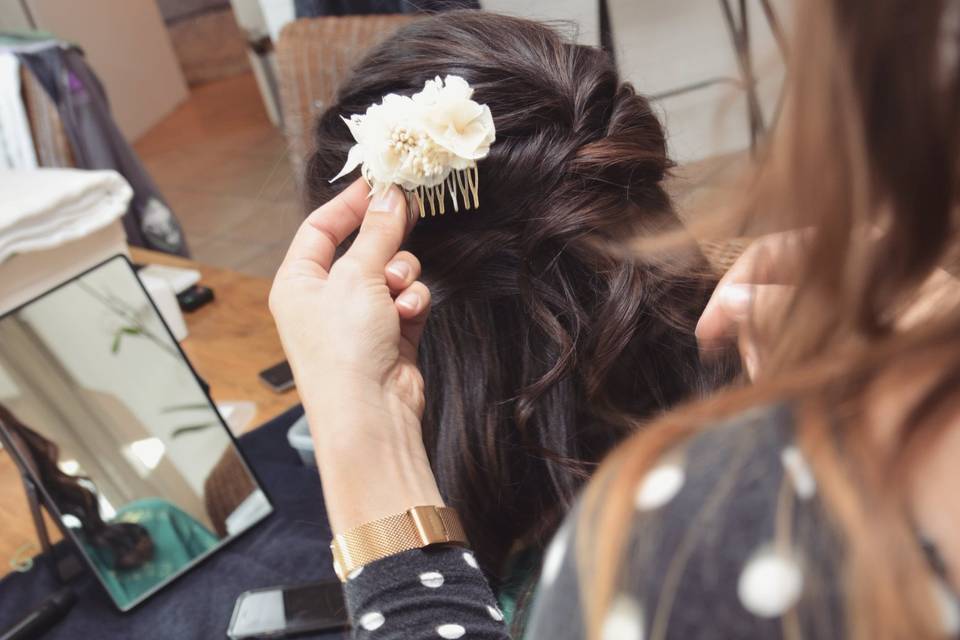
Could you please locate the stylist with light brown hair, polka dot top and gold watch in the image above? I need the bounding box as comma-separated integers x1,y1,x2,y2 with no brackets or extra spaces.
270,0,960,640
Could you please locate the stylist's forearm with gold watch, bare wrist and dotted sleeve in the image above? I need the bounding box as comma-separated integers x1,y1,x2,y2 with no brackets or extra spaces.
304,385,509,640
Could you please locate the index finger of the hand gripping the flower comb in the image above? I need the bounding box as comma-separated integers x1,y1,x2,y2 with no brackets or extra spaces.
282,178,370,272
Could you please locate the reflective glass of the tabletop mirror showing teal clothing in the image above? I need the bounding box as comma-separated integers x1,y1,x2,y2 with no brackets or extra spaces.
0,257,271,609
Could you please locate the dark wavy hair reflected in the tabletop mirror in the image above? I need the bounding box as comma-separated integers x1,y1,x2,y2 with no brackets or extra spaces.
0,404,153,570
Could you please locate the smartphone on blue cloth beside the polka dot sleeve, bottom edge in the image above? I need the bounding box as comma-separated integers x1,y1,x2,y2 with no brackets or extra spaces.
227,581,348,640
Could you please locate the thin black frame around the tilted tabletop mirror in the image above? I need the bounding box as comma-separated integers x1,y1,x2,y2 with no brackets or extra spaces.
0,253,277,613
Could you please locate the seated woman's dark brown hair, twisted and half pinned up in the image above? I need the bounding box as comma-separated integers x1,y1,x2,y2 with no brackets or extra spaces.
306,12,728,579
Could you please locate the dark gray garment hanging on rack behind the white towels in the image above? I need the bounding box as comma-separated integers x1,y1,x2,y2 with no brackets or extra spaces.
17,44,190,256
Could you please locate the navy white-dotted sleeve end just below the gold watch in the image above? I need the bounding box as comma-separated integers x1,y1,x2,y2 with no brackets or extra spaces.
344,547,510,640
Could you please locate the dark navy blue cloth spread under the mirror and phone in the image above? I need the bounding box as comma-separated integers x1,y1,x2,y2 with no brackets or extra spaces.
0,407,344,640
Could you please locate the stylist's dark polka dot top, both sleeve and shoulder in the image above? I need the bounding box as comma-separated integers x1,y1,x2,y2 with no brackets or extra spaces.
345,407,960,640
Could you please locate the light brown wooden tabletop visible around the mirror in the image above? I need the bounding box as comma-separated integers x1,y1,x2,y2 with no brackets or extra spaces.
0,248,300,575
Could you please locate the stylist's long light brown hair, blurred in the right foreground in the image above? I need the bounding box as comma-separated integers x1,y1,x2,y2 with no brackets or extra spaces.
580,0,960,640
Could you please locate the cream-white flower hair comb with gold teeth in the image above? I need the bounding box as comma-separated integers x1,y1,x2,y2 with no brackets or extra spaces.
330,76,496,218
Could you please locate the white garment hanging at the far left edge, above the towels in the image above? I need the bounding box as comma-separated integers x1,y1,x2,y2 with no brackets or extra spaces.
0,51,37,169
